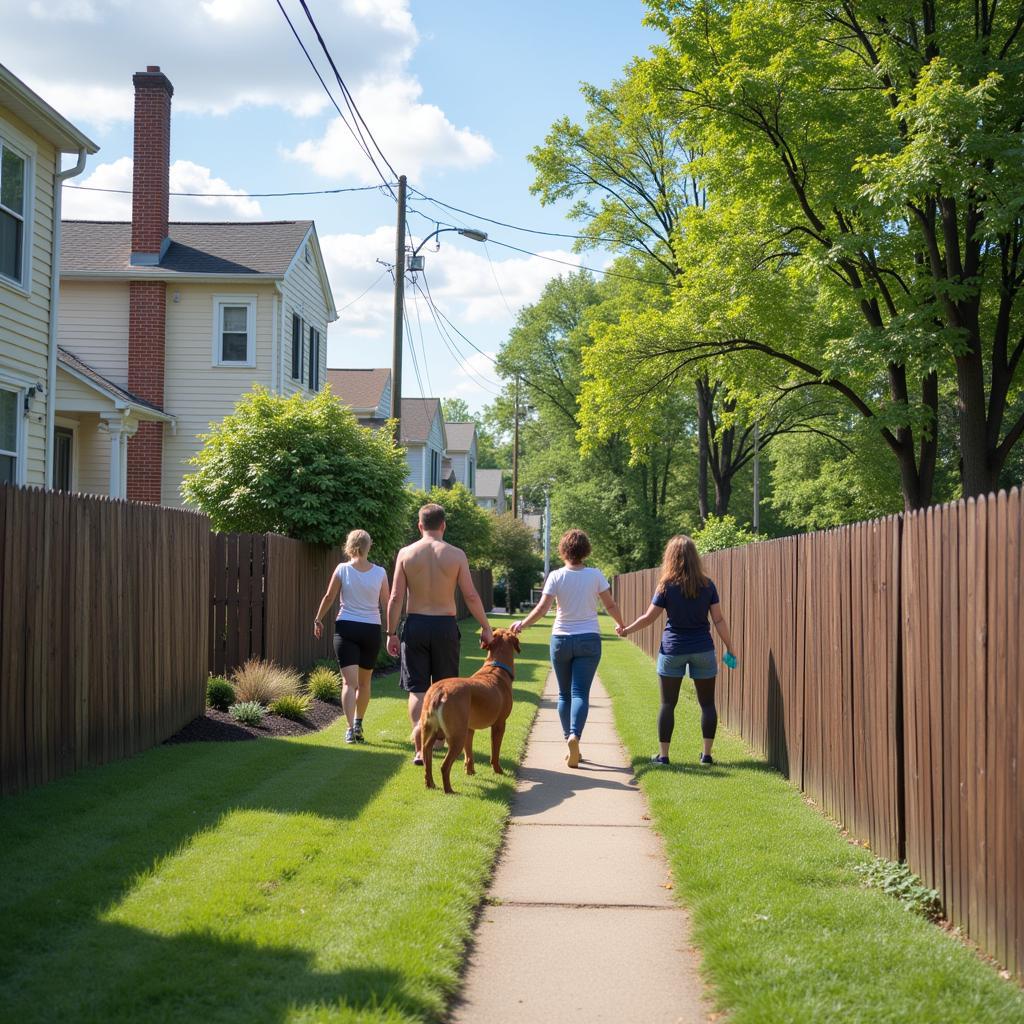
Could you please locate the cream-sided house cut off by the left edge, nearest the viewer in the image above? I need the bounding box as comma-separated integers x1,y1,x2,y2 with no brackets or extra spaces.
0,65,97,486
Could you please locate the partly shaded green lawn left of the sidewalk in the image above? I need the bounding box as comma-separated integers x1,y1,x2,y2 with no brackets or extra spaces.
0,624,548,1024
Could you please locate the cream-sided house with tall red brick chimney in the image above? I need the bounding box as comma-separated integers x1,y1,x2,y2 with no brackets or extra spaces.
56,67,337,505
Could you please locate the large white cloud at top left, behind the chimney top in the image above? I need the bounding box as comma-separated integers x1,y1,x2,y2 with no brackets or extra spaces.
0,0,418,128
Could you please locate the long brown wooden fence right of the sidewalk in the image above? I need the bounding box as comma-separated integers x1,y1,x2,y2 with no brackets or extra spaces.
615,490,1024,975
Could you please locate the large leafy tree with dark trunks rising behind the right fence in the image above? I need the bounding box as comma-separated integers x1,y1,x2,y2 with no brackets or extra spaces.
648,0,1024,499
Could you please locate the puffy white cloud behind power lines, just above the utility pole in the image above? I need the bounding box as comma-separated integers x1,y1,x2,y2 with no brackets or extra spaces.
287,77,495,182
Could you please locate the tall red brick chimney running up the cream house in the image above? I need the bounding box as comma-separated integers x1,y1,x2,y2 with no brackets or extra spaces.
128,66,174,505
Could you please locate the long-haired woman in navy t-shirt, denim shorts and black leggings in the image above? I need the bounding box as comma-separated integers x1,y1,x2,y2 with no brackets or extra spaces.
615,535,732,765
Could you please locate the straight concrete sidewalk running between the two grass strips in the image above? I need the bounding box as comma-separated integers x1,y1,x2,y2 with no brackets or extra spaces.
451,676,708,1024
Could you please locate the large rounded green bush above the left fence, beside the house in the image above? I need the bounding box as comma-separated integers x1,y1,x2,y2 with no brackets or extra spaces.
181,387,409,559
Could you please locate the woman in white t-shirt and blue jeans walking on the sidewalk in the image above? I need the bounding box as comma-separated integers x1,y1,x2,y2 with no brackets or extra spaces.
512,529,623,768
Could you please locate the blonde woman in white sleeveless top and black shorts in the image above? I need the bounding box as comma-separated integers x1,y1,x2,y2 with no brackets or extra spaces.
313,529,390,743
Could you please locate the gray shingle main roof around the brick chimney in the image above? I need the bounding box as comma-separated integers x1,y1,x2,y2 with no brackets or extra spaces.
60,220,312,278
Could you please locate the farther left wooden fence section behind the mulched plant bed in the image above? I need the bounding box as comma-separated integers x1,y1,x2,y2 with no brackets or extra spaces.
209,534,494,675
